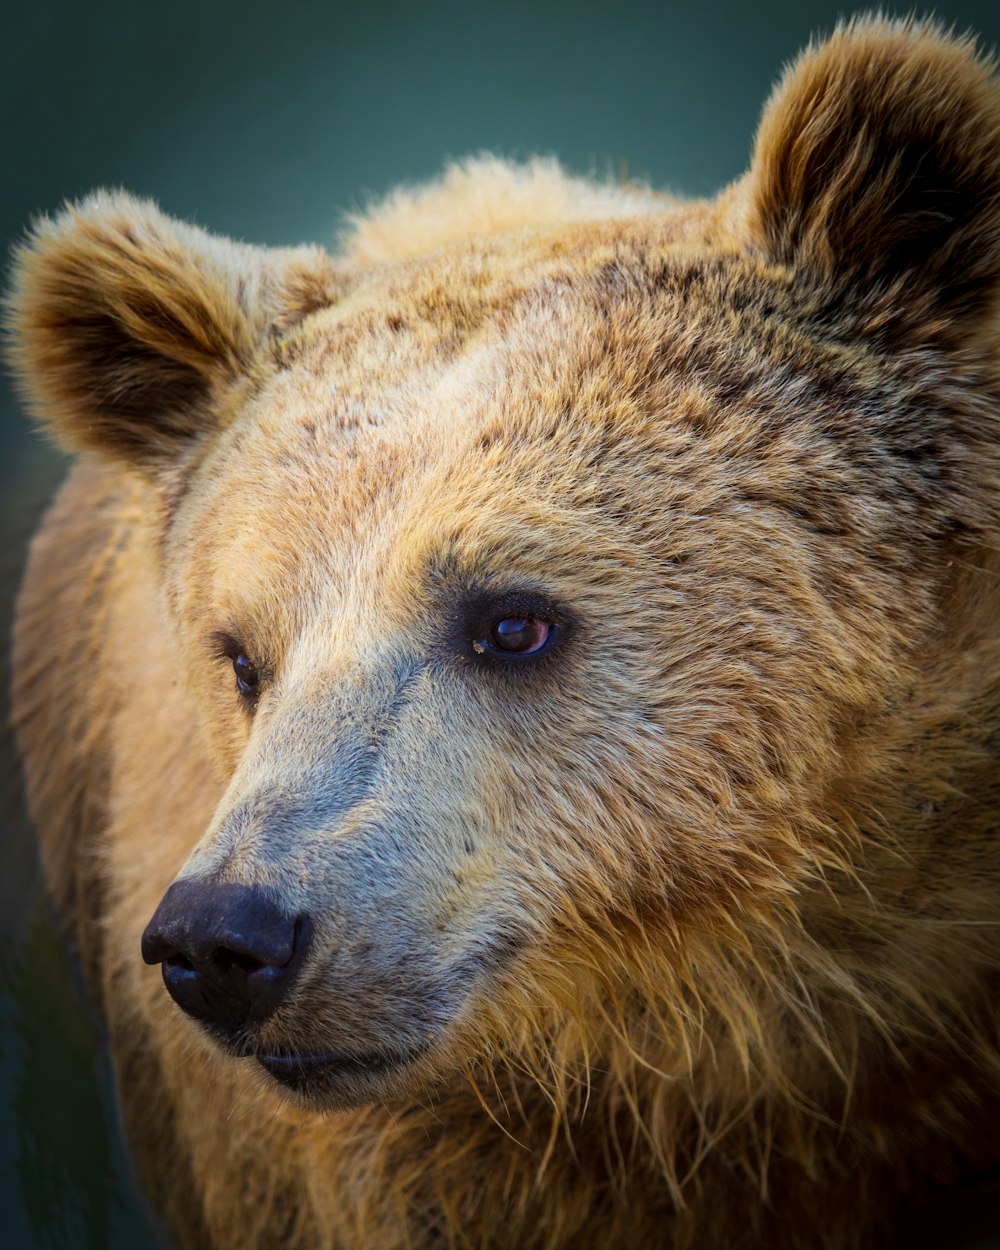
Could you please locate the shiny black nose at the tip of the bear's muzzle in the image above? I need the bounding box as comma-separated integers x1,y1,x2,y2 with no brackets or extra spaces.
143,881,313,1036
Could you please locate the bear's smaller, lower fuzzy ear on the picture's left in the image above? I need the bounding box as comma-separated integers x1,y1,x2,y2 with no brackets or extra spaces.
8,193,341,474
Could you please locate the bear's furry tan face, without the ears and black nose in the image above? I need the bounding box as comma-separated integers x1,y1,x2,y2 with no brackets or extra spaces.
138,220,985,1105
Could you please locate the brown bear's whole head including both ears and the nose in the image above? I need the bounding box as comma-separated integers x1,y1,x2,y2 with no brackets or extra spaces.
5,24,1000,1244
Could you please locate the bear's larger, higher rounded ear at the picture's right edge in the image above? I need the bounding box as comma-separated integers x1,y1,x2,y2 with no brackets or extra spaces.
744,19,1000,340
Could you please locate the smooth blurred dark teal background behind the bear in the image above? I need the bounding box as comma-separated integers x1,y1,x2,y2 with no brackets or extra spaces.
0,0,1000,1250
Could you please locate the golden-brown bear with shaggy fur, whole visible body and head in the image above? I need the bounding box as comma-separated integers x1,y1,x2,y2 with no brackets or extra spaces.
5,20,1000,1250
